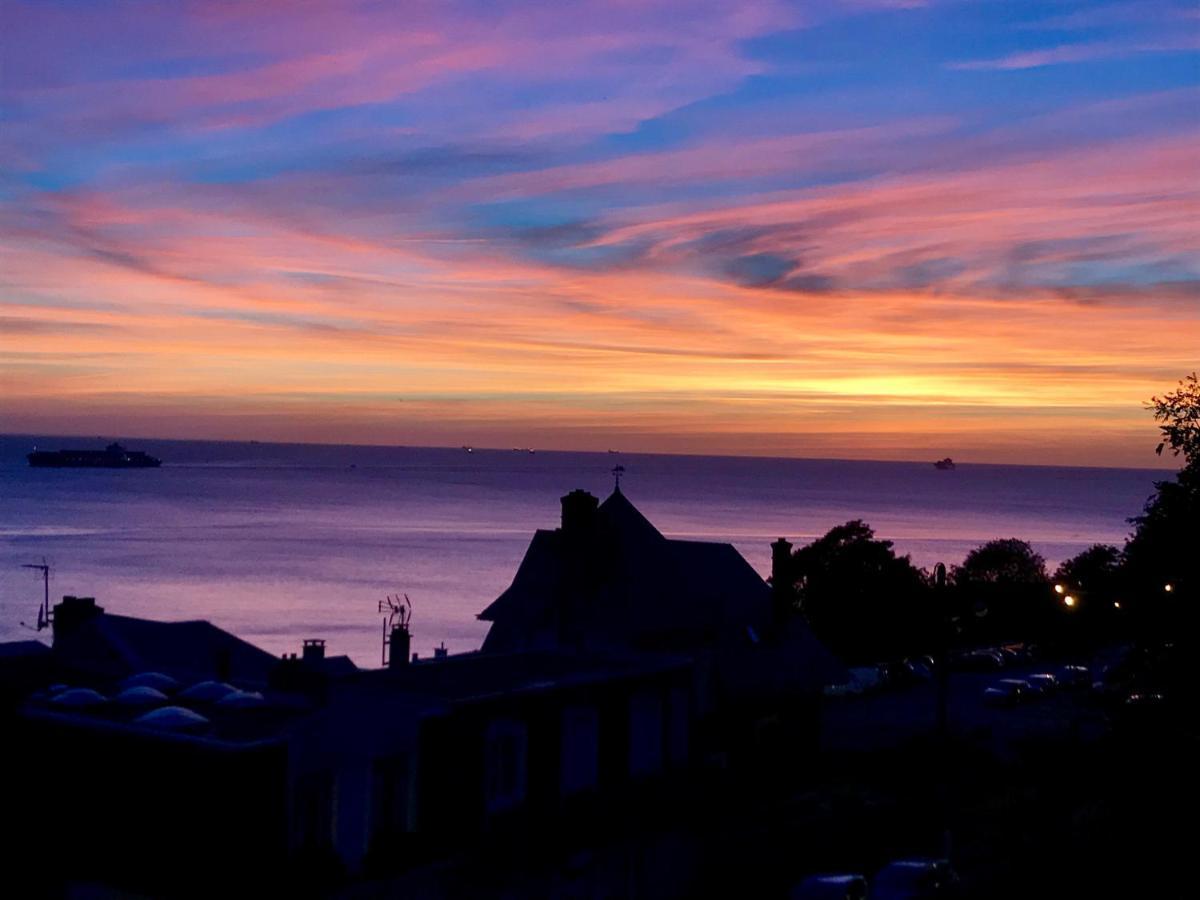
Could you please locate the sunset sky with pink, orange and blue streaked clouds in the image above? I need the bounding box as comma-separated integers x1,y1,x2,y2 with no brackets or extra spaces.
0,0,1200,466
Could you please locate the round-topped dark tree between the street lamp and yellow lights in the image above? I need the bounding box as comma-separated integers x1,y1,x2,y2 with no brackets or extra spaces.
950,538,1055,640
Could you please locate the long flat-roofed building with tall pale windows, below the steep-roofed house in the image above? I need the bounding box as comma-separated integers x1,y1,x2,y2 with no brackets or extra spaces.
348,652,691,895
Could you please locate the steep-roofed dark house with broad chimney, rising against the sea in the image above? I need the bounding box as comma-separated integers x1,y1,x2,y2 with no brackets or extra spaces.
479,488,845,763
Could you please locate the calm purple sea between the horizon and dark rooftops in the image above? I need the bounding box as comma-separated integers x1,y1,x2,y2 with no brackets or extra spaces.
0,436,1166,665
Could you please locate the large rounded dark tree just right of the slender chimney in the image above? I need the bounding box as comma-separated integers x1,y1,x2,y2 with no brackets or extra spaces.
792,518,935,662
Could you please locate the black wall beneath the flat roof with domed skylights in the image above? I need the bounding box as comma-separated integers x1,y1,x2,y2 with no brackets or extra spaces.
7,718,287,895
